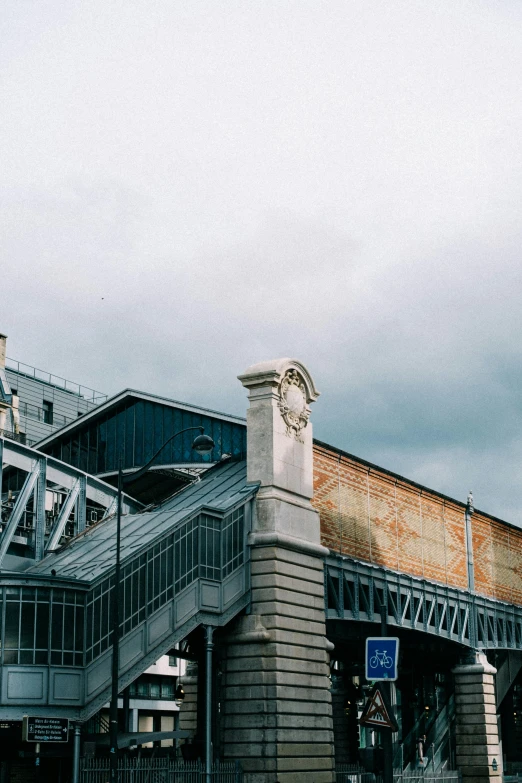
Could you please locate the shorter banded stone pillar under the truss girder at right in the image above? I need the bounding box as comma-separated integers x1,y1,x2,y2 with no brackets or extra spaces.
453,651,502,783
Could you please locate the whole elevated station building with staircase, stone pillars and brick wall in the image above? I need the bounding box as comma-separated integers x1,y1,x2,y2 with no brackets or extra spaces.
0,338,522,783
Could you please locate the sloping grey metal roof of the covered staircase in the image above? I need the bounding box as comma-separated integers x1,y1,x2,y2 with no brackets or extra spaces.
26,460,258,582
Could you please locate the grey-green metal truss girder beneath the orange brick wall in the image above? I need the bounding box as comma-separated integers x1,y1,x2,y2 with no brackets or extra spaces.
325,555,522,650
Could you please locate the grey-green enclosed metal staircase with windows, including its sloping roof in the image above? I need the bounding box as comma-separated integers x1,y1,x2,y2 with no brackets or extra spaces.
0,460,258,722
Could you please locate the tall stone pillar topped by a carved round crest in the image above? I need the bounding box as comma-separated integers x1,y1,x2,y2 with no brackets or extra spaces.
221,359,333,783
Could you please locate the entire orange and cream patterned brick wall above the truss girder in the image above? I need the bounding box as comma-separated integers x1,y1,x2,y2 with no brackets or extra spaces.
313,446,522,605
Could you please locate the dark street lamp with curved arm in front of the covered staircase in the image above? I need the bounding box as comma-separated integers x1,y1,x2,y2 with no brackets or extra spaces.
109,426,215,783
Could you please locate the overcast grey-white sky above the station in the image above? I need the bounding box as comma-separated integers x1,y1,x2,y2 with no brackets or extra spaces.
0,0,522,524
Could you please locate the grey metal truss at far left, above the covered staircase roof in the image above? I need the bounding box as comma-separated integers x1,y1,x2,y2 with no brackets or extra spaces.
0,437,142,568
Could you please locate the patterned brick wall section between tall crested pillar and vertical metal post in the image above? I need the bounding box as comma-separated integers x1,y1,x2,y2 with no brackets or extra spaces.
313,444,468,592
